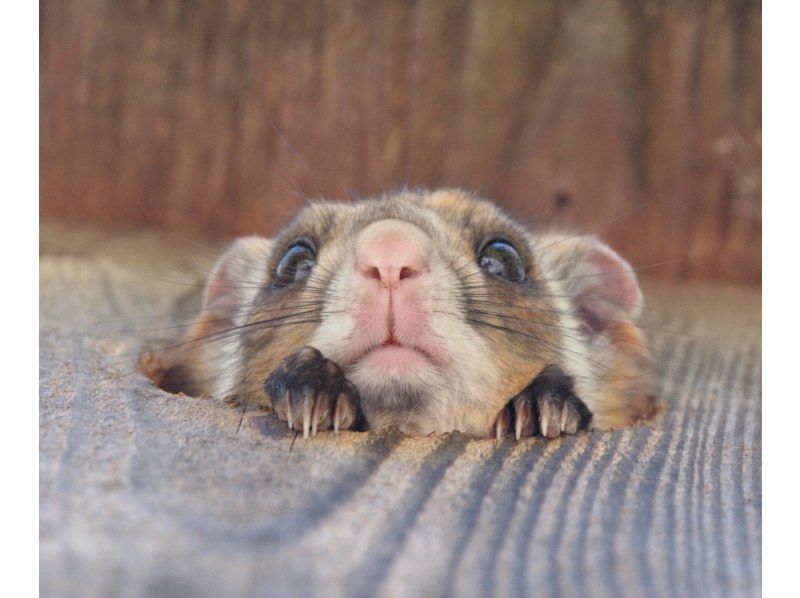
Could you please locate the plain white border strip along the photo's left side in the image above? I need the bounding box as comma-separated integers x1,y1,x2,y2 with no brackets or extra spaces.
0,2,39,596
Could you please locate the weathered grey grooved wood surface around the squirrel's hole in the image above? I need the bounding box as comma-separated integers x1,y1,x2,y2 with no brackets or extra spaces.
40,227,761,597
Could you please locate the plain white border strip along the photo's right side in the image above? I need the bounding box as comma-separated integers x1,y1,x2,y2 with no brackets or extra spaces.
762,2,800,596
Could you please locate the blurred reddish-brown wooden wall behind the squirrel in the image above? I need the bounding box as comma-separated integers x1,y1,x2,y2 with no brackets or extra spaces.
40,0,761,284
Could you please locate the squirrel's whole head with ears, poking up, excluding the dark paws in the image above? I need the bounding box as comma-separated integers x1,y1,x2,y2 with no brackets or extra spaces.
143,190,650,434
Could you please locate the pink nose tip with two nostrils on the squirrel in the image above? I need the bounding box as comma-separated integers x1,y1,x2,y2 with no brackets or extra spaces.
356,219,430,288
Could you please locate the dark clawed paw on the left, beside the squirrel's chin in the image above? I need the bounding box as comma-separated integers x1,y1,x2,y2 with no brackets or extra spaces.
264,346,359,438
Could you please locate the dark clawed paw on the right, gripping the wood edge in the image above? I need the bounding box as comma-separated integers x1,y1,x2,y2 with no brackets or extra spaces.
495,364,592,440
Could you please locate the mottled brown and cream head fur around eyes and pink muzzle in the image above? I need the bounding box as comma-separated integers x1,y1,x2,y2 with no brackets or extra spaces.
141,190,657,435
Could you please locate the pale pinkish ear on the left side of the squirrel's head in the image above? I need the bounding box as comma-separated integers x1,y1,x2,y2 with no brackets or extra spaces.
202,237,272,323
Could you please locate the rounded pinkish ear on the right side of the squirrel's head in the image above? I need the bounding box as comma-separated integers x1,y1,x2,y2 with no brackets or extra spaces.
537,235,644,334
